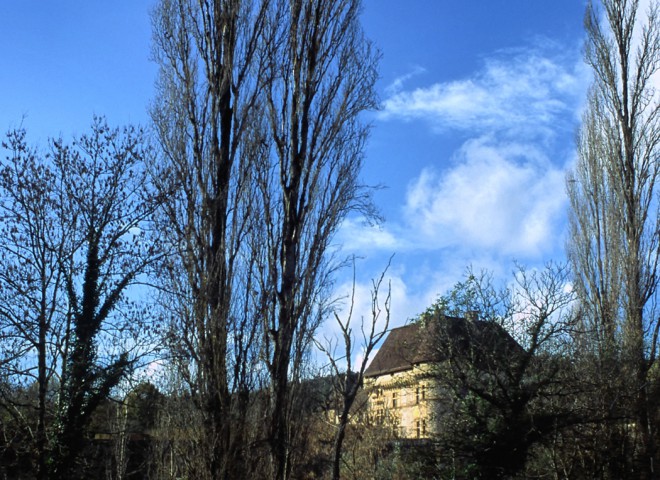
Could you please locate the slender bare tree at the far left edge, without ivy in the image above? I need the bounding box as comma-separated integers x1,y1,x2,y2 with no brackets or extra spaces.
0,130,71,478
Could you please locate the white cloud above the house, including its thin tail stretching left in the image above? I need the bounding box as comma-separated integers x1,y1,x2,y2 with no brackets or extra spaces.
338,136,572,267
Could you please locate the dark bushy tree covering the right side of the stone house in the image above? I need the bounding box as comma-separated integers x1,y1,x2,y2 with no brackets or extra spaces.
421,264,589,479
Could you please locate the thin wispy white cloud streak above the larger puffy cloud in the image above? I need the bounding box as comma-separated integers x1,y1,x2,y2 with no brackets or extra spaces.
380,42,588,140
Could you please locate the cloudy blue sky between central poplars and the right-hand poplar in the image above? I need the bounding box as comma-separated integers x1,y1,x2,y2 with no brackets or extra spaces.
342,0,590,326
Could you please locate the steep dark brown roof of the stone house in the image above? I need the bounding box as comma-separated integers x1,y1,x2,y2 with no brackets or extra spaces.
364,314,522,377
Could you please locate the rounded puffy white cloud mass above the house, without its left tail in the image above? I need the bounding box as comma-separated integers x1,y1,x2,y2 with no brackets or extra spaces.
405,138,566,256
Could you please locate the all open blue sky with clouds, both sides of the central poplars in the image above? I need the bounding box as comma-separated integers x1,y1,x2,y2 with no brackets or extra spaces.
0,0,590,326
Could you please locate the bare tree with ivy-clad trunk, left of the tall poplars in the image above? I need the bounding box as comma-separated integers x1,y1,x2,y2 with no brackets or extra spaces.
49,118,159,478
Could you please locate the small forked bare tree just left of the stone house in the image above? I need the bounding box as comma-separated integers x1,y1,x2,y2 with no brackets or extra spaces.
315,260,392,480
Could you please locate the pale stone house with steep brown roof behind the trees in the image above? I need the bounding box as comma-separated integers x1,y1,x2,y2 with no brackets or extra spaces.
365,314,521,439
